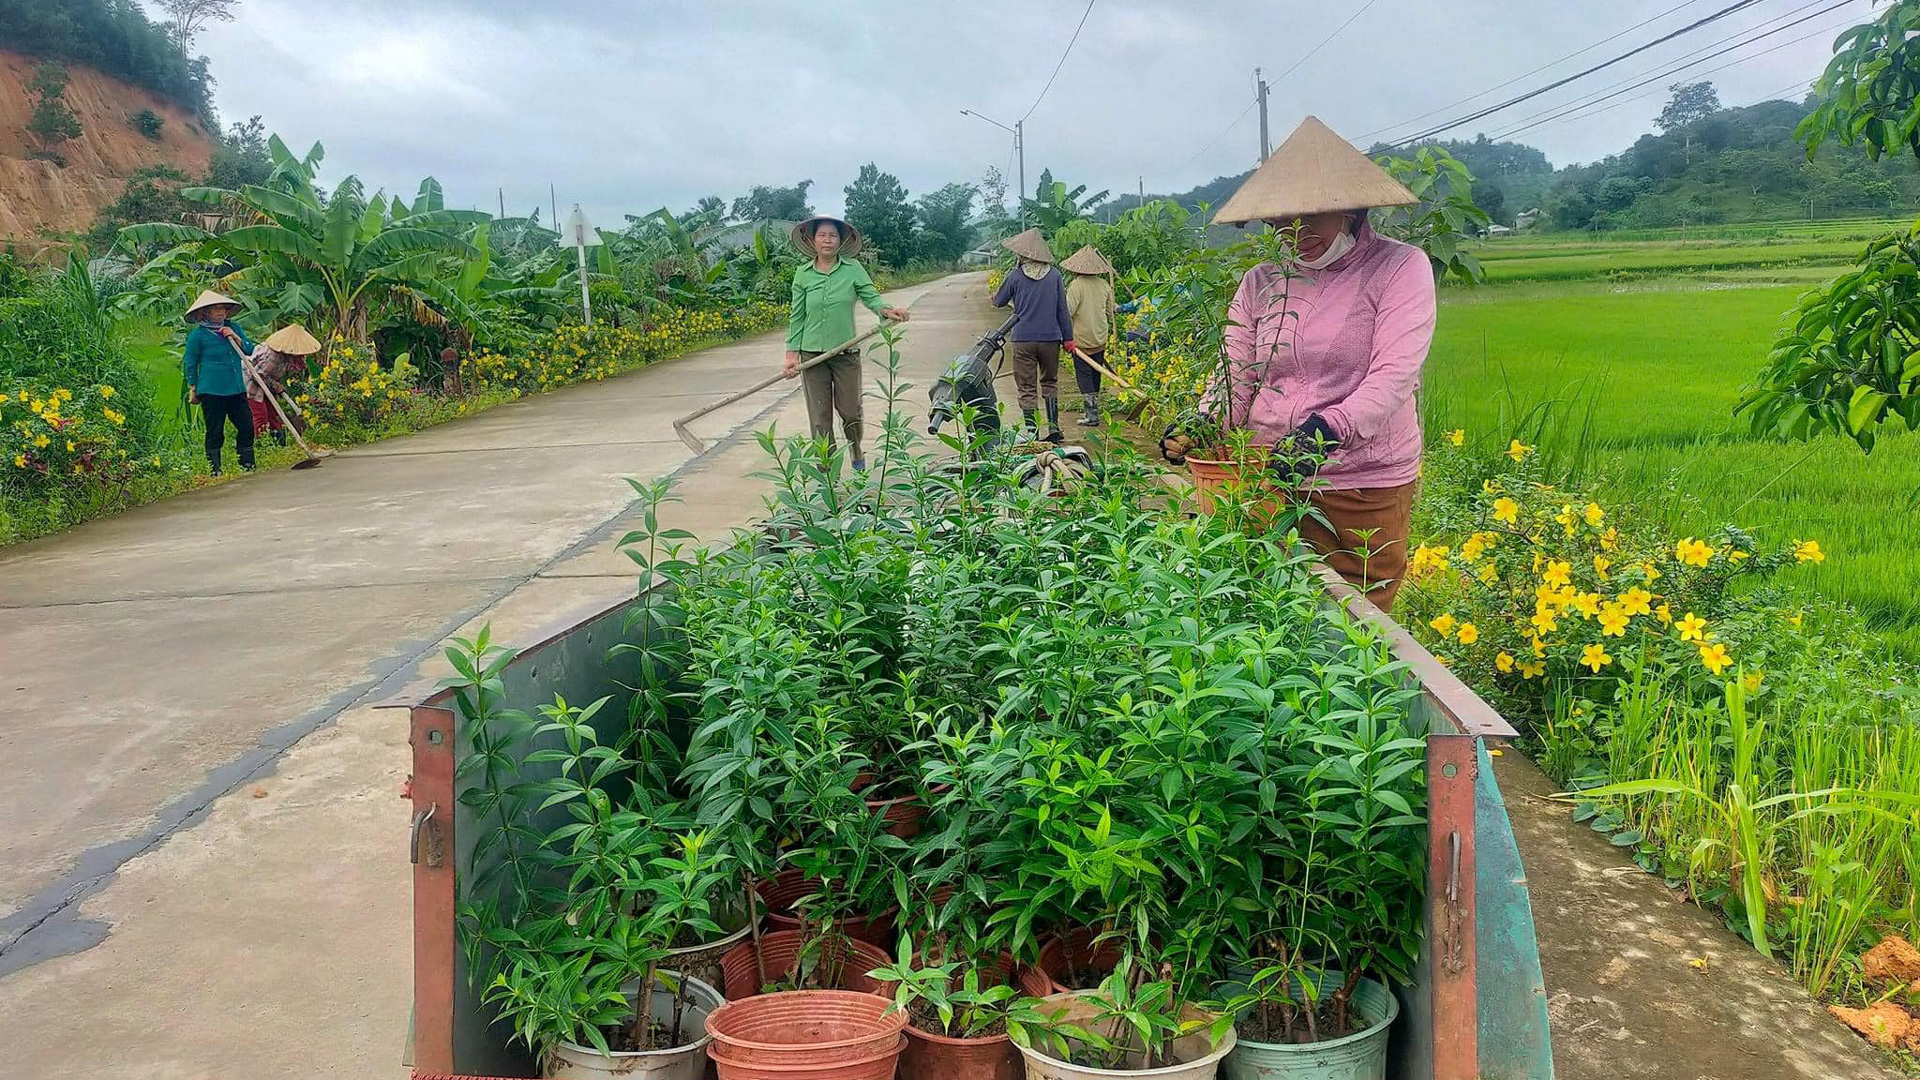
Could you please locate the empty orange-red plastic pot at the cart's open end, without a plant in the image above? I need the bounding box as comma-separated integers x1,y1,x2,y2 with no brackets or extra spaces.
707,990,906,1080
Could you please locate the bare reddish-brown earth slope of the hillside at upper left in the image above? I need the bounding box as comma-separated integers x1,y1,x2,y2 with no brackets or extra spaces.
0,50,213,240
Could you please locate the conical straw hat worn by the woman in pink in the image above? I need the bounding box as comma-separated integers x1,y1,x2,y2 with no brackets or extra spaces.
1213,117,1419,225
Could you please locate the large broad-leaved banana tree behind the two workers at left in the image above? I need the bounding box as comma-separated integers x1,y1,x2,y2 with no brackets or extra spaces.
121,140,488,340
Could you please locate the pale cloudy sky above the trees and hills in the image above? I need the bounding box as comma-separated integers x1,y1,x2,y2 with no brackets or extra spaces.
176,0,1868,225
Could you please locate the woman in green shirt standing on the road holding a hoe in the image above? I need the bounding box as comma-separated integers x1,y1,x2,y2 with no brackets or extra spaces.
785,215,906,471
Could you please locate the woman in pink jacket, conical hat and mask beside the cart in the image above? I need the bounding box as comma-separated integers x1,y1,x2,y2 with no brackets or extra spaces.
1162,117,1434,609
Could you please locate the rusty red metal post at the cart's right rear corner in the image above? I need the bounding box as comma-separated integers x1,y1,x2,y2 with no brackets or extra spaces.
1427,732,1480,1080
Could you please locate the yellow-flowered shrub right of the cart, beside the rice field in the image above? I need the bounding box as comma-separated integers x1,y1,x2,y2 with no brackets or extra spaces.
1400,432,1826,717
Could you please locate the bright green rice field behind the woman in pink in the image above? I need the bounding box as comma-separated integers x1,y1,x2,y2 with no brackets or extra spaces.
1423,265,1920,659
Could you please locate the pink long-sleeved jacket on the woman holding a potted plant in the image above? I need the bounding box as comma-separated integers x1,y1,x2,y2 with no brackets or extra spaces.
1208,225,1434,490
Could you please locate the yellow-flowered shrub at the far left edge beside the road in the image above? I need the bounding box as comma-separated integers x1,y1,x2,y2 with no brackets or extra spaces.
0,382,159,494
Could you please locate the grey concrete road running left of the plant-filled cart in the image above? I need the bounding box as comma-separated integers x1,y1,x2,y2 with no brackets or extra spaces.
0,275,998,1078
